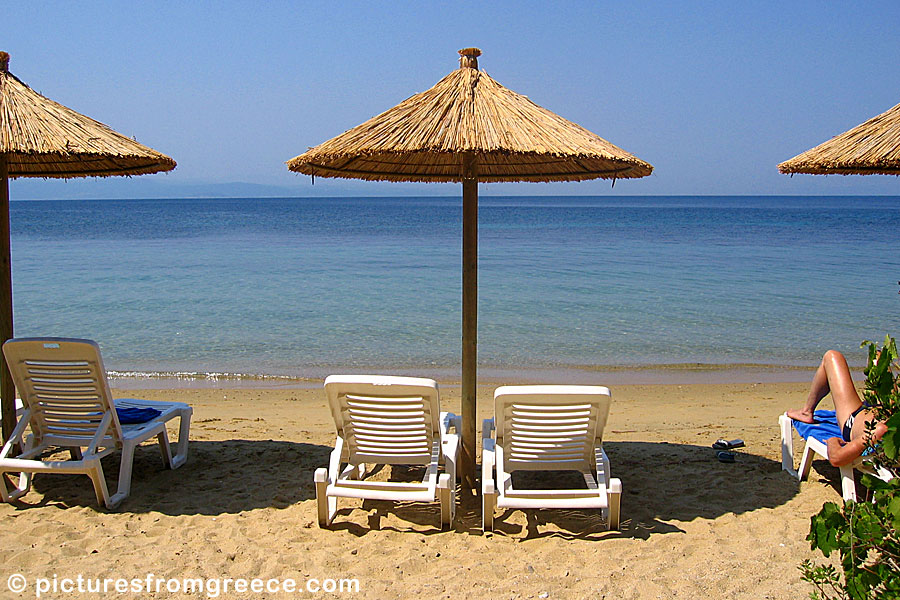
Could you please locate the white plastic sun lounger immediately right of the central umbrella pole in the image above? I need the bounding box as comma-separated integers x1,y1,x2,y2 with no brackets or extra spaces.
481,385,622,531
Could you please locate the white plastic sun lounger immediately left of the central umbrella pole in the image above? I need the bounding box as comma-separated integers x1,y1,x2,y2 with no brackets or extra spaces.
314,375,461,528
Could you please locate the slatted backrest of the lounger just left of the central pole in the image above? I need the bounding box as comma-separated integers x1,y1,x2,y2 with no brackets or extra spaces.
325,375,440,465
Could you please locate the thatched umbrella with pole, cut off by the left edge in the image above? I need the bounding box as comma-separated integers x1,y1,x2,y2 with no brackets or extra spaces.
0,52,175,439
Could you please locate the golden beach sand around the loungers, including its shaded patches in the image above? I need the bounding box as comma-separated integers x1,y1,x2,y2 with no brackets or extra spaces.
0,383,852,600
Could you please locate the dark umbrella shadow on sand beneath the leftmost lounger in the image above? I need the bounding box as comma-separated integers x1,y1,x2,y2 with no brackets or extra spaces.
23,440,332,516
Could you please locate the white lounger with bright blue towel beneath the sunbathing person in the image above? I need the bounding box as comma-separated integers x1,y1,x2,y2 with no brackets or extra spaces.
778,411,894,502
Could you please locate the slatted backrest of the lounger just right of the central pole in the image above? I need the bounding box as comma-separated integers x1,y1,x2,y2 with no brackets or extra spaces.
494,385,610,472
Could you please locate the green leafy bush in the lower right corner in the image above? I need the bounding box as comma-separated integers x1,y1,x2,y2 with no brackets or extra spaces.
800,336,900,600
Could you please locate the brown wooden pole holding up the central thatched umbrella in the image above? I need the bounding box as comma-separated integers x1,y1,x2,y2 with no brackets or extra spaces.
460,154,478,489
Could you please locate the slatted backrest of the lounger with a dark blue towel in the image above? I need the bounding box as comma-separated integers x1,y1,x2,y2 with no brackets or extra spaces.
3,338,121,446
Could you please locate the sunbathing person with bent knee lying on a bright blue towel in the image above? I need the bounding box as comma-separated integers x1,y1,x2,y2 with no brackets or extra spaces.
787,350,887,467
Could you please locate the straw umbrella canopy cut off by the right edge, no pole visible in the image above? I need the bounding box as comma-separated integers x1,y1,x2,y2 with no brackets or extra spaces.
778,99,900,175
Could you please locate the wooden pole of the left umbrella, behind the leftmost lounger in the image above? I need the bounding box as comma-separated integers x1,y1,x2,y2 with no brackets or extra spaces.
0,156,16,441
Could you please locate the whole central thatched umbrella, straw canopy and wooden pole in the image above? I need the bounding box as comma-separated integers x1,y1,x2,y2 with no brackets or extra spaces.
287,48,653,484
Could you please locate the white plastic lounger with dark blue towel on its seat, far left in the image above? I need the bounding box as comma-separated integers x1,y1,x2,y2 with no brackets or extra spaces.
0,338,192,509
